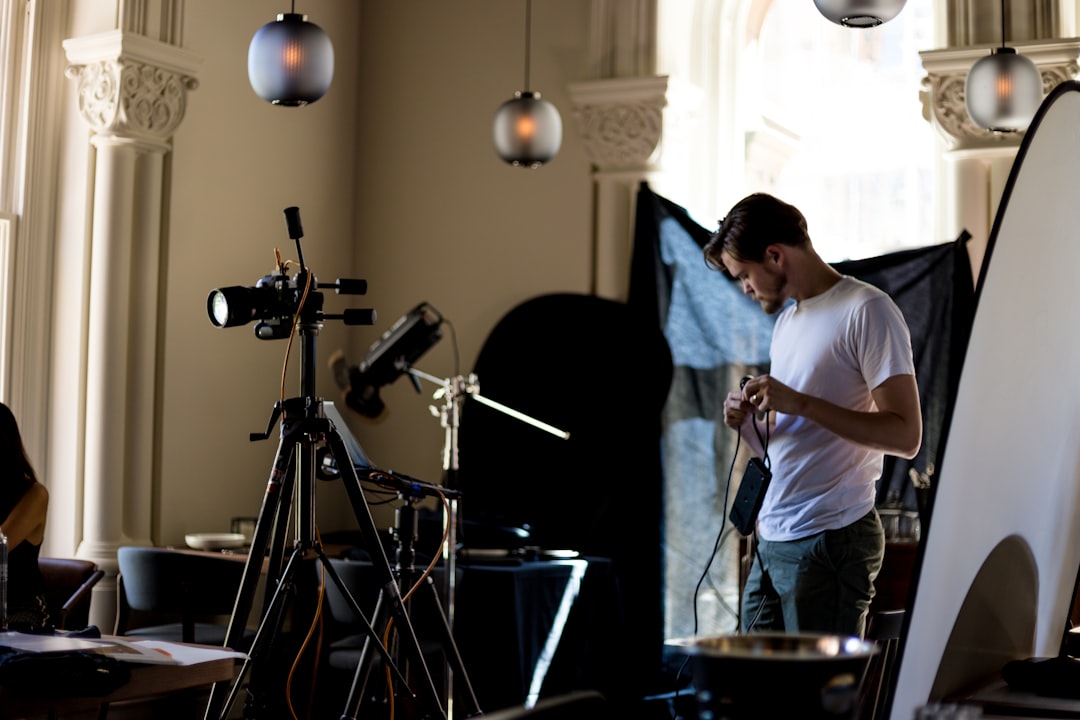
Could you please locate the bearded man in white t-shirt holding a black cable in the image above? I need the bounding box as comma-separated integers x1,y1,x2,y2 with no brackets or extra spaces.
704,193,922,636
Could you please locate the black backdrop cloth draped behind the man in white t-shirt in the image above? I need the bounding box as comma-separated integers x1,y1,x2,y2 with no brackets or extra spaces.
629,184,974,637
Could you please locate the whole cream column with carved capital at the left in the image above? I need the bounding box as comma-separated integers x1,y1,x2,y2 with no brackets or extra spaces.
64,30,198,629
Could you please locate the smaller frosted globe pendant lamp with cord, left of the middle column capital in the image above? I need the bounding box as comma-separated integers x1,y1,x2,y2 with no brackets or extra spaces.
495,0,563,168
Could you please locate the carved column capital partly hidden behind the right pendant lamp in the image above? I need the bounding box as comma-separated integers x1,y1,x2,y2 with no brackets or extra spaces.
919,38,1080,150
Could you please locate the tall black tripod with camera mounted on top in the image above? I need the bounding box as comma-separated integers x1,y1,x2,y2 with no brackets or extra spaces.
205,207,446,720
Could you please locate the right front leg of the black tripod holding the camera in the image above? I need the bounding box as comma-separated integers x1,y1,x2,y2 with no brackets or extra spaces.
326,427,446,718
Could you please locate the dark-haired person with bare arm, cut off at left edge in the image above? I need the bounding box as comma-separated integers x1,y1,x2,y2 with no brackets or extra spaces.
0,403,49,630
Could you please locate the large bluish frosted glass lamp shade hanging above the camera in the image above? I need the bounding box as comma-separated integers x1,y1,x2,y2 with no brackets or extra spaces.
247,13,334,107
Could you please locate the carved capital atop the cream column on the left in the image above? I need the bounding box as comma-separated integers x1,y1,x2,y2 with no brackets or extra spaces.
64,30,201,151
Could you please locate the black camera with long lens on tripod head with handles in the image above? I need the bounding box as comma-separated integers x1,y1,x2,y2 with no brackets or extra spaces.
206,207,376,340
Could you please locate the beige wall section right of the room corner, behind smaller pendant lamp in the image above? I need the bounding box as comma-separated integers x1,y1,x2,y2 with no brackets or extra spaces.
352,0,592,524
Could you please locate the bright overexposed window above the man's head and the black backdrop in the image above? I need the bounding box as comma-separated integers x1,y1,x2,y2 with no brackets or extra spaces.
743,0,939,261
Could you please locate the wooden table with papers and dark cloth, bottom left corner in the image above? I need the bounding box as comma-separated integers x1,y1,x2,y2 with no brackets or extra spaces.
0,643,235,720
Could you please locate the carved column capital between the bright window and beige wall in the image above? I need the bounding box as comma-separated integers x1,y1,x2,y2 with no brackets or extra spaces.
568,77,667,171
